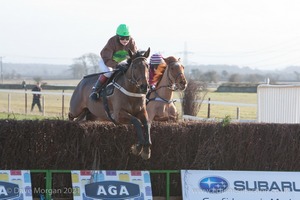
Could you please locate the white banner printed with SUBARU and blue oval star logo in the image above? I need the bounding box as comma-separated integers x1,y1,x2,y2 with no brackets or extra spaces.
181,170,300,200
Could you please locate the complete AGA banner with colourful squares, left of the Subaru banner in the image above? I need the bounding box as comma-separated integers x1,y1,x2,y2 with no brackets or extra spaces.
71,170,152,200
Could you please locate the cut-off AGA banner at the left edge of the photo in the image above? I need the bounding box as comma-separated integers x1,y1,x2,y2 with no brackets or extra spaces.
0,170,32,200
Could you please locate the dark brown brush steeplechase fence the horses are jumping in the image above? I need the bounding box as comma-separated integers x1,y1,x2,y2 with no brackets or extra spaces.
0,120,300,200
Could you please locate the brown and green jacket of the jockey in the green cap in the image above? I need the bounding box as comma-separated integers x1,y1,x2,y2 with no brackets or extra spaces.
100,35,137,68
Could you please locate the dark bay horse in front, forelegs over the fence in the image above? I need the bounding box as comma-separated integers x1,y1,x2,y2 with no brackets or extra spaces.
69,48,151,159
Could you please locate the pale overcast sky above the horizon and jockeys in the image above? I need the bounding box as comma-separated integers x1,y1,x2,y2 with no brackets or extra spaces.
0,0,300,69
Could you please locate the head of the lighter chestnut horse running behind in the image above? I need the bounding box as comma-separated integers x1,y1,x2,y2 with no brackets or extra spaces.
164,56,187,90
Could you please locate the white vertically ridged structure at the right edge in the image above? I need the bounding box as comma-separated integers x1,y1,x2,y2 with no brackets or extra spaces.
257,84,300,123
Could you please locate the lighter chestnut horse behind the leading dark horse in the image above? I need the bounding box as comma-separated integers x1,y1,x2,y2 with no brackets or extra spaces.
147,56,187,123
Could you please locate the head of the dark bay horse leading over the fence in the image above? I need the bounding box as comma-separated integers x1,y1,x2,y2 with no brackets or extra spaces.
126,48,150,94
